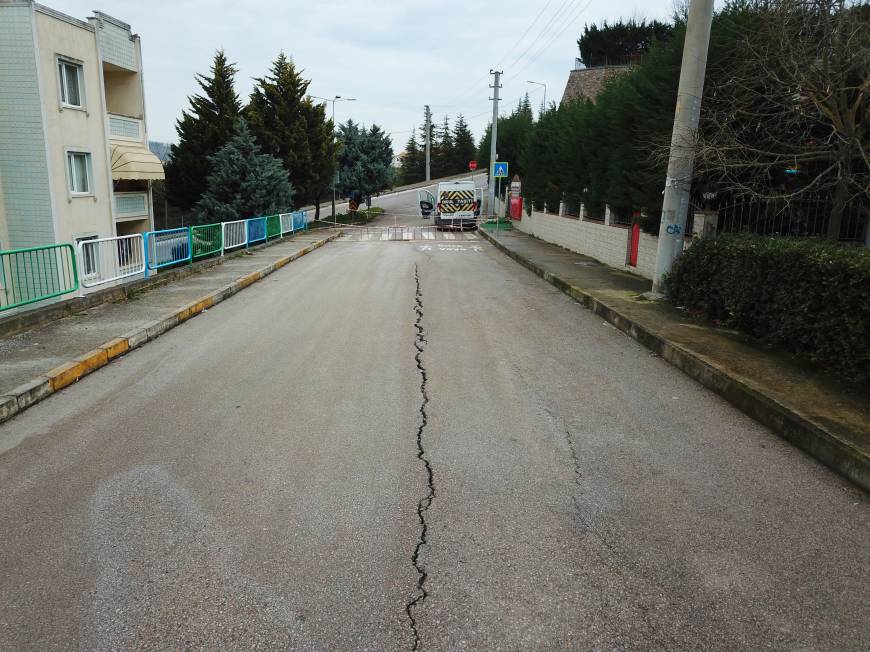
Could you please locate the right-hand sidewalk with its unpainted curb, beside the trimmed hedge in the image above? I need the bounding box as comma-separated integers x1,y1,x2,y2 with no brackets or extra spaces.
481,230,870,490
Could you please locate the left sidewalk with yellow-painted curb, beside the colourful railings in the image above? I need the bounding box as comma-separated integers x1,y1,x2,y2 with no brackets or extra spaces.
0,229,340,423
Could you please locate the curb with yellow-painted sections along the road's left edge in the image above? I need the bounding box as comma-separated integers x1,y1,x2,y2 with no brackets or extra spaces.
0,232,341,423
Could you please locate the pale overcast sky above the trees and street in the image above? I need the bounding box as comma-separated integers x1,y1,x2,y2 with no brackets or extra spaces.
59,0,673,152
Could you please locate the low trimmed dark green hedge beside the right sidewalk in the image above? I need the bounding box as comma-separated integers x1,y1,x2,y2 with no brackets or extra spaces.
667,235,870,385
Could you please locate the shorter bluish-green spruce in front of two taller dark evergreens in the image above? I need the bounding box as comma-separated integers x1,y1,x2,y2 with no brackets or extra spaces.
196,118,293,224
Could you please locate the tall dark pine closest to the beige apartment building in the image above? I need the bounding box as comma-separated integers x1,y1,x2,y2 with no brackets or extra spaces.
166,50,242,210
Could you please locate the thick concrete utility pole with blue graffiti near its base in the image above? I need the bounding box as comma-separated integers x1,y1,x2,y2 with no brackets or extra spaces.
652,0,713,294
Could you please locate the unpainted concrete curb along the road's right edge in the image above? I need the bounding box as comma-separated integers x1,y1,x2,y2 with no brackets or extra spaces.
478,229,870,491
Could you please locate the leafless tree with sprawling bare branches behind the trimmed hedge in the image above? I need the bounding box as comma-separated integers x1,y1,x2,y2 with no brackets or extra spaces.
697,0,870,239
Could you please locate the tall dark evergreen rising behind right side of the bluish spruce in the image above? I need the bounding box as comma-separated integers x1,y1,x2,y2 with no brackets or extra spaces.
245,52,319,201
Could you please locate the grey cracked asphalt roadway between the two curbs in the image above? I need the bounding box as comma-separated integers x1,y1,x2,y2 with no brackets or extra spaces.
0,186,870,650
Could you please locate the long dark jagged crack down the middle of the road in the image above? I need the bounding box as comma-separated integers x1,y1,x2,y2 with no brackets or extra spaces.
405,265,435,650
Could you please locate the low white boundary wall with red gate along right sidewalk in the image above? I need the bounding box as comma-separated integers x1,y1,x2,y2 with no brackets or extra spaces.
513,211,658,280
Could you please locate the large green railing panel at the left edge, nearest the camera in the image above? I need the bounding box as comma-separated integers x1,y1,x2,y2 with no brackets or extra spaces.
0,244,79,312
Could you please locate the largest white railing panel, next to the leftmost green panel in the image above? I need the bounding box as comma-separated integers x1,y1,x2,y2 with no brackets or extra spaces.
77,233,145,288
